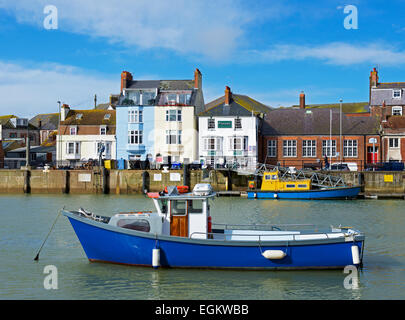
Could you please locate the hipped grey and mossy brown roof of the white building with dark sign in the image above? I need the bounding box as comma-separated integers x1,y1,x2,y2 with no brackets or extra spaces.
199,93,271,117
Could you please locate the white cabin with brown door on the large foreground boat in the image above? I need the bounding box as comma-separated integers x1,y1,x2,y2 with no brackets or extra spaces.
109,184,215,239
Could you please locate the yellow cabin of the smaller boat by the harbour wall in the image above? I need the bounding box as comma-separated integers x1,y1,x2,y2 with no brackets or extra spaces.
261,170,311,191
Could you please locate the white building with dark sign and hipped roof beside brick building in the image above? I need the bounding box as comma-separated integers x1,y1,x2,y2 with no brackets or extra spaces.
198,86,270,169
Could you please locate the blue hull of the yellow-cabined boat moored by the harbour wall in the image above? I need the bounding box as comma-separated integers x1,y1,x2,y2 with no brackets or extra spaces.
247,187,360,200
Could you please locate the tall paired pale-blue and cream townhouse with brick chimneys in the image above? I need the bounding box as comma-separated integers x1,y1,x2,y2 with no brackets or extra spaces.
116,69,204,163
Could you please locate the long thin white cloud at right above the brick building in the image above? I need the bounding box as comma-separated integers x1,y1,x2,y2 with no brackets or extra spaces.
241,42,405,66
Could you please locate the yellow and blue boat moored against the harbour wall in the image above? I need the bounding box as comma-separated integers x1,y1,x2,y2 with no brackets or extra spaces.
247,170,360,200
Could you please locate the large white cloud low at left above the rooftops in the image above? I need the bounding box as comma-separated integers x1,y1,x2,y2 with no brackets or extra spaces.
0,61,120,117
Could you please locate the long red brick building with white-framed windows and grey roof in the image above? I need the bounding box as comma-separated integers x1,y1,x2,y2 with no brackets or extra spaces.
259,107,380,170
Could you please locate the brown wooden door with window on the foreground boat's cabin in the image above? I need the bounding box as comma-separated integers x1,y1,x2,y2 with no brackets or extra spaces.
170,200,190,237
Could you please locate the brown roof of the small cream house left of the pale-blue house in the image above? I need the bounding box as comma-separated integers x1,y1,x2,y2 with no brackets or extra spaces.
61,109,116,126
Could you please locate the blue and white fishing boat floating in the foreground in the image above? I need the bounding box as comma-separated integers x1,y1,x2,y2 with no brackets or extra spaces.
62,184,364,269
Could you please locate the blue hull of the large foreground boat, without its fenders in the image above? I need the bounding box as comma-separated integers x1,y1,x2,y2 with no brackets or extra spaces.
65,214,364,269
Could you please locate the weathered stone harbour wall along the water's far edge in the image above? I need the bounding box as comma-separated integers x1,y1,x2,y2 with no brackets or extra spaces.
0,169,405,197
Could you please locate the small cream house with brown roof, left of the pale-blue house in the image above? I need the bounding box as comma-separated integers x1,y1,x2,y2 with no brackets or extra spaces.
56,105,116,165
